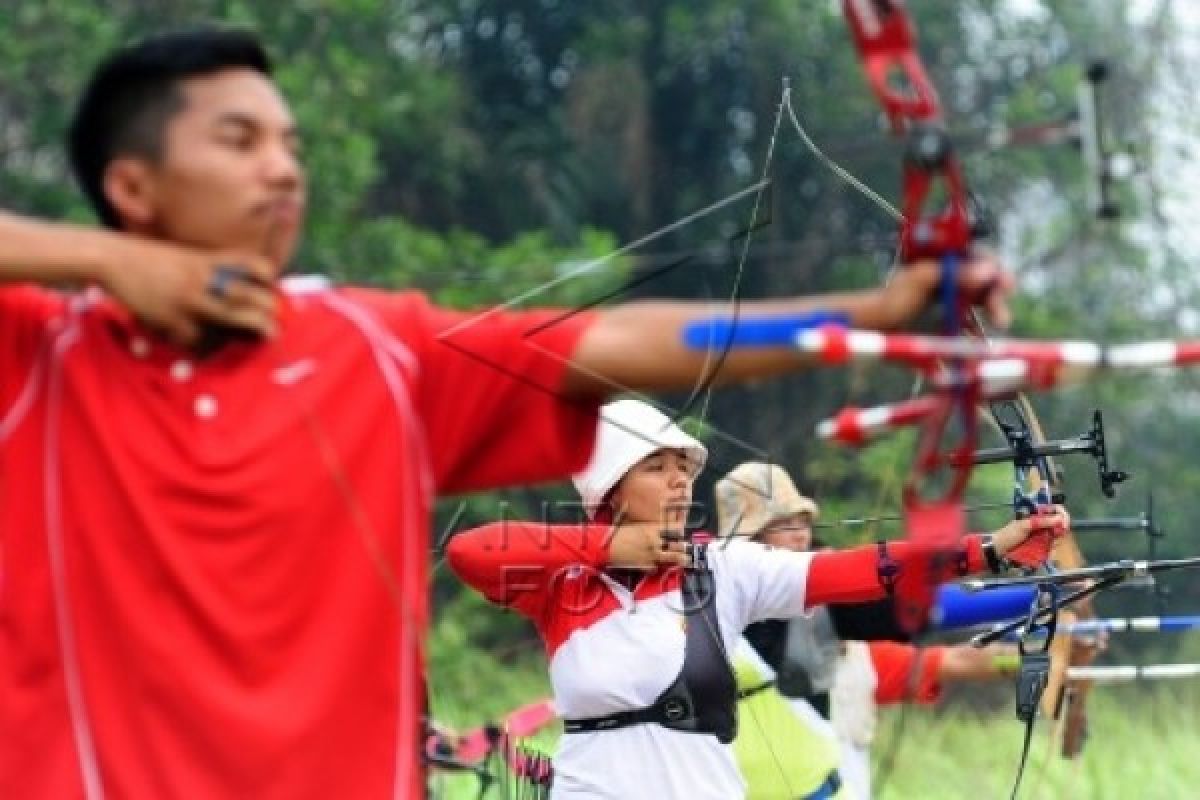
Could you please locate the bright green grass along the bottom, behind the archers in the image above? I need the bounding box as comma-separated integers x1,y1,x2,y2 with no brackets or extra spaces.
434,654,1200,800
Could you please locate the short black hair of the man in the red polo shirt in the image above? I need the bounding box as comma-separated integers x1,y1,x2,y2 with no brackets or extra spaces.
67,28,271,228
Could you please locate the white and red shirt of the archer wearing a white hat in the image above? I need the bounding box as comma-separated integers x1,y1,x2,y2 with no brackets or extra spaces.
446,522,812,800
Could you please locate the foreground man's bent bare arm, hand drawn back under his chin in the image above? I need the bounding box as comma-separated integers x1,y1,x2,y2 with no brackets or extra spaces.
0,211,276,344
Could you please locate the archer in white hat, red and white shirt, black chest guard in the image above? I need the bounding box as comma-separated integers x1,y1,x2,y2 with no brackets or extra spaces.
446,399,1063,800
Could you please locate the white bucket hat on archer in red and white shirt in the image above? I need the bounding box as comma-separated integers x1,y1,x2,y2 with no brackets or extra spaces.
571,399,708,517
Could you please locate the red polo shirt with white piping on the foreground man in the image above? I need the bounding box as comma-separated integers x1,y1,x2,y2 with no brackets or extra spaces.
0,282,596,800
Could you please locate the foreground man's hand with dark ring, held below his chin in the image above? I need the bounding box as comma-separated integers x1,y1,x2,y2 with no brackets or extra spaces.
97,236,277,347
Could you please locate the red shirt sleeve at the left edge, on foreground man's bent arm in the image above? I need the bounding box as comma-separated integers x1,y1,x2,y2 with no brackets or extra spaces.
0,285,64,431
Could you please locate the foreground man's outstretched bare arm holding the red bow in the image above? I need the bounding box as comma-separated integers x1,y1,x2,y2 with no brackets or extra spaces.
564,258,1013,396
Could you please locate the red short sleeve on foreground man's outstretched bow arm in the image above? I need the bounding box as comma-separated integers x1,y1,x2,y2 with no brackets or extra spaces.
352,293,602,494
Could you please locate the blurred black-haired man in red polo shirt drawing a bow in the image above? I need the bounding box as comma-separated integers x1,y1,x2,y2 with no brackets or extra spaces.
0,26,1010,800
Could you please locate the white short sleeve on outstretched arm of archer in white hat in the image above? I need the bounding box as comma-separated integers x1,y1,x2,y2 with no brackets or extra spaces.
708,539,812,632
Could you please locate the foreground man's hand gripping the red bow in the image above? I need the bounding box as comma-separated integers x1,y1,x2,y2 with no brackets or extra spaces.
877,252,1016,330
